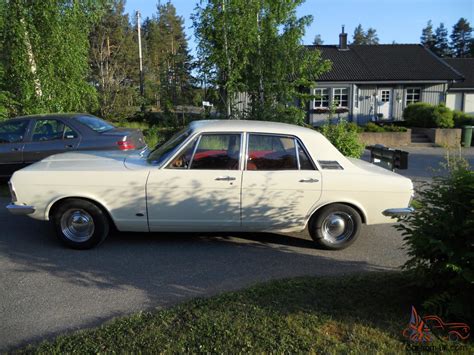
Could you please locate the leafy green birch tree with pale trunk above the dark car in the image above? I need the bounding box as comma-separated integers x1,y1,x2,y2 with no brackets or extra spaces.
1,0,97,113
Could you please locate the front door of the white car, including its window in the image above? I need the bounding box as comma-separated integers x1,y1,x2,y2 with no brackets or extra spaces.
147,133,242,231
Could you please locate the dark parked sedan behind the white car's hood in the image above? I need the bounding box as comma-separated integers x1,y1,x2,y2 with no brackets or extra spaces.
0,114,145,178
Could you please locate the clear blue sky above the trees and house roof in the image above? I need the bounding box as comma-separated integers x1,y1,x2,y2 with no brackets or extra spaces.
126,0,474,53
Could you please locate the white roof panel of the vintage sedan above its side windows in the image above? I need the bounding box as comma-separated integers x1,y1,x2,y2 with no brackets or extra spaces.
190,120,318,135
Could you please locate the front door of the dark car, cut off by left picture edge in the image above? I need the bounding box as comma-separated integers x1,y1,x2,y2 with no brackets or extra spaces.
0,119,29,177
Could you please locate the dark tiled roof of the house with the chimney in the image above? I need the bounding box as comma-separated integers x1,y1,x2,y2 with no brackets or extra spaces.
307,44,463,82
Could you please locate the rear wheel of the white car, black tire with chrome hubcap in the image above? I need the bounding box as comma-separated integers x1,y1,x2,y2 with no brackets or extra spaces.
309,203,362,250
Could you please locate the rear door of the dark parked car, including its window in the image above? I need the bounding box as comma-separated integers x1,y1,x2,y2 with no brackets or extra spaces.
23,118,80,163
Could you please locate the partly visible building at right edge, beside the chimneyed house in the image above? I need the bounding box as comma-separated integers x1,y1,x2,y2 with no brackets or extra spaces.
444,58,474,114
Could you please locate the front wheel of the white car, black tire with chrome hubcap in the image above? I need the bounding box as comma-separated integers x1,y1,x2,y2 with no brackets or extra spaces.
51,199,110,249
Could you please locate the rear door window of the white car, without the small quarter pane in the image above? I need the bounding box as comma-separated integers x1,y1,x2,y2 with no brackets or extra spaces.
247,134,298,171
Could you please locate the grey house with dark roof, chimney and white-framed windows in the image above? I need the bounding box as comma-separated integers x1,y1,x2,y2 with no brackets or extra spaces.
308,28,464,125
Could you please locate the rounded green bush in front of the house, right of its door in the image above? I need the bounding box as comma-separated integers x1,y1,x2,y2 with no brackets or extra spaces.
403,102,454,128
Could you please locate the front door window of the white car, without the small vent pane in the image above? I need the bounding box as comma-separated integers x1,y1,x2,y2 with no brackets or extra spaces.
189,134,240,170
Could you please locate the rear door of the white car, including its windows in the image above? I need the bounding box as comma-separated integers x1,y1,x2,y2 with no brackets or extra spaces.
242,133,322,230
